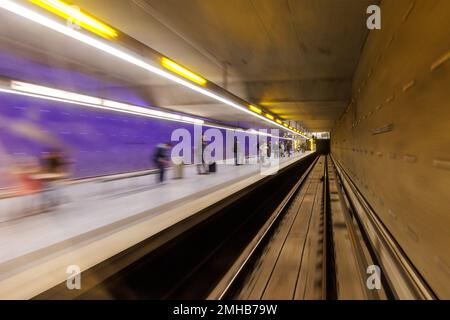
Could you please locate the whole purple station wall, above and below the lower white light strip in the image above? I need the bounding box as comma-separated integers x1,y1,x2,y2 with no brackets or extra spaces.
0,52,278,187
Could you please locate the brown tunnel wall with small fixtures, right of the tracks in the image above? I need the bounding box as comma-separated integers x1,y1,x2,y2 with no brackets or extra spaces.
332,0,450,299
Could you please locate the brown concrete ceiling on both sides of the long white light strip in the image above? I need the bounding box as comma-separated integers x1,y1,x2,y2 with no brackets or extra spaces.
1,0,374,131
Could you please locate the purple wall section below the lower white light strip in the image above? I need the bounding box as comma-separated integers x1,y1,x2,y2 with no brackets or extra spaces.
0,94,197,178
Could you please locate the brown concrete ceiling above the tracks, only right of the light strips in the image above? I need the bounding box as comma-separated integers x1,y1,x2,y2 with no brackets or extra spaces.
136,0,373,130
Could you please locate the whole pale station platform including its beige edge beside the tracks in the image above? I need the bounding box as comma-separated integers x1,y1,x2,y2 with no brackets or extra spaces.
0,151,312,298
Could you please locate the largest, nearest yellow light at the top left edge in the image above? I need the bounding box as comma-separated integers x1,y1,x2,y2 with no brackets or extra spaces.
29,0,118,39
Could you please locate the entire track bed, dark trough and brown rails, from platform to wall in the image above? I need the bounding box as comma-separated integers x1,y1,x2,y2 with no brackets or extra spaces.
36,152,434,300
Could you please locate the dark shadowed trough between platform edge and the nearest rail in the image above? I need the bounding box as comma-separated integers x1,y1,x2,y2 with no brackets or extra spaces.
36,155,316,299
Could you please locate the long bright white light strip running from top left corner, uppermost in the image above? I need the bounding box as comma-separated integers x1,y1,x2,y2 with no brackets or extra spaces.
0,0,309,139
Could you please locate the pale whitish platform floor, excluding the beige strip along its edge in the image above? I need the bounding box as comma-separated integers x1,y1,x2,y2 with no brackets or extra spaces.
0,153,309,268
